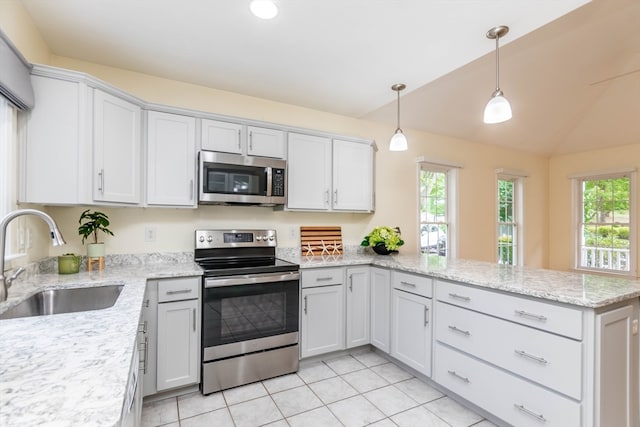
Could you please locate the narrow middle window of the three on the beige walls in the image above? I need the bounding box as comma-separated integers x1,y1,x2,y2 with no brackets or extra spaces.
496,169,526,265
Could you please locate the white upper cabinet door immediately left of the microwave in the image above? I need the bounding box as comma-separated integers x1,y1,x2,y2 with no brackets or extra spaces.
147,111,196,207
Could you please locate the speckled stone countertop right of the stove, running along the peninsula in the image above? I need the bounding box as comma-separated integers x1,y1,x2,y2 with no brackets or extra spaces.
279,251,640,308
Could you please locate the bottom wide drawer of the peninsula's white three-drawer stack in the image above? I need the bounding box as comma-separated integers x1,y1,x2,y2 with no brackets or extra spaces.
434,343,582,427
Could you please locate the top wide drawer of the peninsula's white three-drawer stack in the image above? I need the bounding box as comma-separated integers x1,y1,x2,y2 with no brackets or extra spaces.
435,280,582,340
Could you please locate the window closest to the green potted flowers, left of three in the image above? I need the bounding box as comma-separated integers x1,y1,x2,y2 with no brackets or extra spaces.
419,163,457,257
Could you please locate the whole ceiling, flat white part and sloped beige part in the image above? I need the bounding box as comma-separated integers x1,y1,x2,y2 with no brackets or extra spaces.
22,0,640,155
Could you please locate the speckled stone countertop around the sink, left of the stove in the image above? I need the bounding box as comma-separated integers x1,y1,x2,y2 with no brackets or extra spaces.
0,255,202,427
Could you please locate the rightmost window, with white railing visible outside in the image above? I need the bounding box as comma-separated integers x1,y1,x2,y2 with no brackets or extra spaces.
576,172,635,274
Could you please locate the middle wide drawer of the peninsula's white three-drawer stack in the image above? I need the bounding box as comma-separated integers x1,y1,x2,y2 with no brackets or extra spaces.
435,301,582,400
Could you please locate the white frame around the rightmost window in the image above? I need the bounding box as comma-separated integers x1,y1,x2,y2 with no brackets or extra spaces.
570,168,638,277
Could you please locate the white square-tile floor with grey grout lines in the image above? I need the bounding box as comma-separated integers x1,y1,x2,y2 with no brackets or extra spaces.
142,351,495,427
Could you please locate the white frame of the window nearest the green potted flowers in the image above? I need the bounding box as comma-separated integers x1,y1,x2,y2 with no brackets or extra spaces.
416,158,462,259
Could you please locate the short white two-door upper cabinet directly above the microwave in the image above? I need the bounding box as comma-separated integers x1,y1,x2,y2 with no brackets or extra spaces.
200,119,284,159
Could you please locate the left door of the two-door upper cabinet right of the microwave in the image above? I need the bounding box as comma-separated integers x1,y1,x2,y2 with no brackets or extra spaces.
287,133,331,210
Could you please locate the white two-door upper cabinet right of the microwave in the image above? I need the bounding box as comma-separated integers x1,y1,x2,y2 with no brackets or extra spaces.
287,133,373,212
